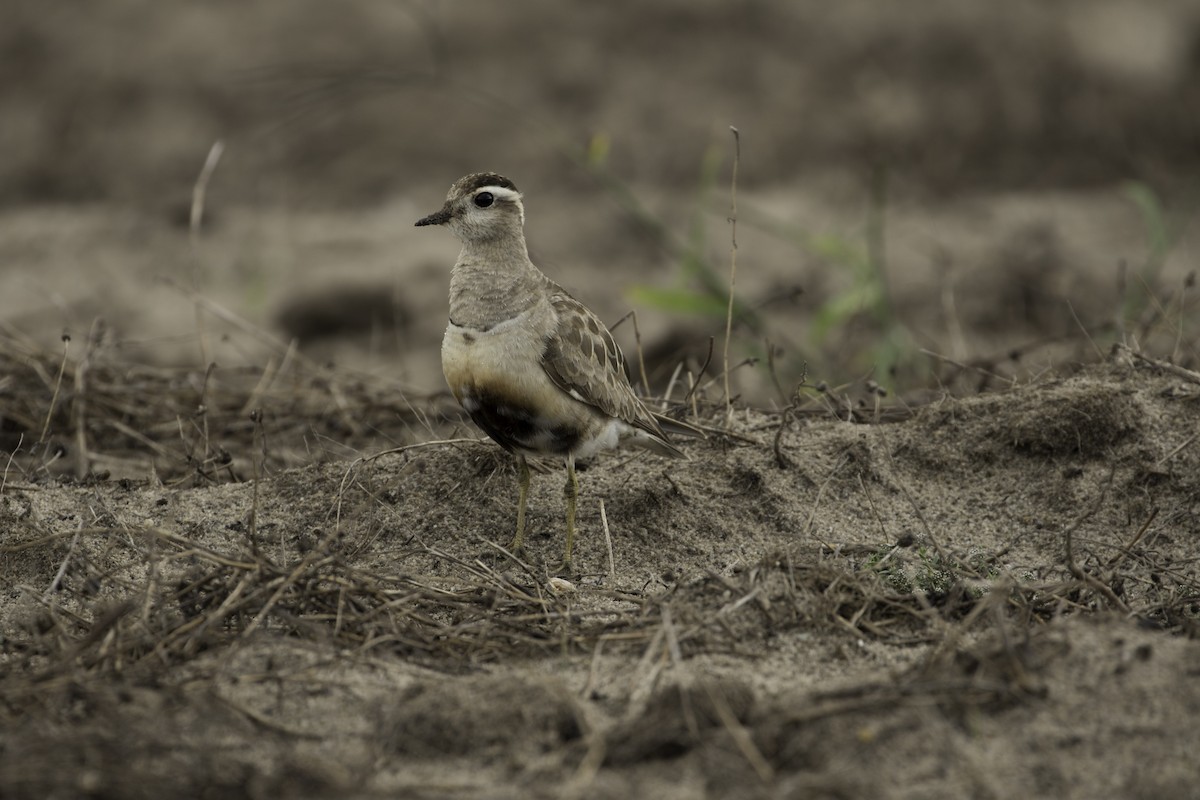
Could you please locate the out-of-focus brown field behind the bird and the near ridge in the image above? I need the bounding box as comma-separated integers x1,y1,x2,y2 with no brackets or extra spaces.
0,0,1200,404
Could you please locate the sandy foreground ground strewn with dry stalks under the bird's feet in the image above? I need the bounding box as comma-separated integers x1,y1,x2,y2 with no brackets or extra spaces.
0,353,1200,798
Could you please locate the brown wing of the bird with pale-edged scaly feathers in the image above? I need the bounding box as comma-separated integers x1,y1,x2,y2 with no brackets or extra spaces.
542,285,666,440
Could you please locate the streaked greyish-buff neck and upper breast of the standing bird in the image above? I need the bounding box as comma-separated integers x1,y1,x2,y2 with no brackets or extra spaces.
450,239,546,331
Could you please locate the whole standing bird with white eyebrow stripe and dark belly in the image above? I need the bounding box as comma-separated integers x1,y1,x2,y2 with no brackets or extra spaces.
416,173,703,575
